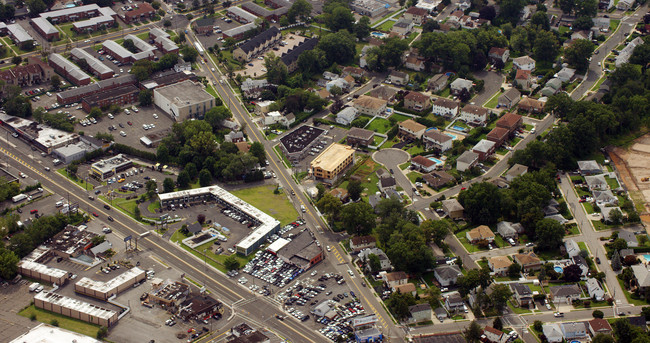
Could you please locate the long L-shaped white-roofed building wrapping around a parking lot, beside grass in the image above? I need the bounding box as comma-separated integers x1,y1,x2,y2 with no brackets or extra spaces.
158,186,280,255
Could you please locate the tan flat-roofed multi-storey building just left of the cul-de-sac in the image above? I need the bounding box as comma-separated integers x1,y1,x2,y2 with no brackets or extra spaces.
310,143,354,182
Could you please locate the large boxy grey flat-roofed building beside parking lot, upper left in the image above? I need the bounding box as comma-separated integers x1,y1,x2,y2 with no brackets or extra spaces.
153,80,215,122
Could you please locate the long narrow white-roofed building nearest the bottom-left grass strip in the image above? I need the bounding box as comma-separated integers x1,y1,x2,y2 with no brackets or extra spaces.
34,292,118,328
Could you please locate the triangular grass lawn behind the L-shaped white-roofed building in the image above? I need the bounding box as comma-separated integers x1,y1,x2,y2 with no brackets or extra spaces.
231,186,299,225
